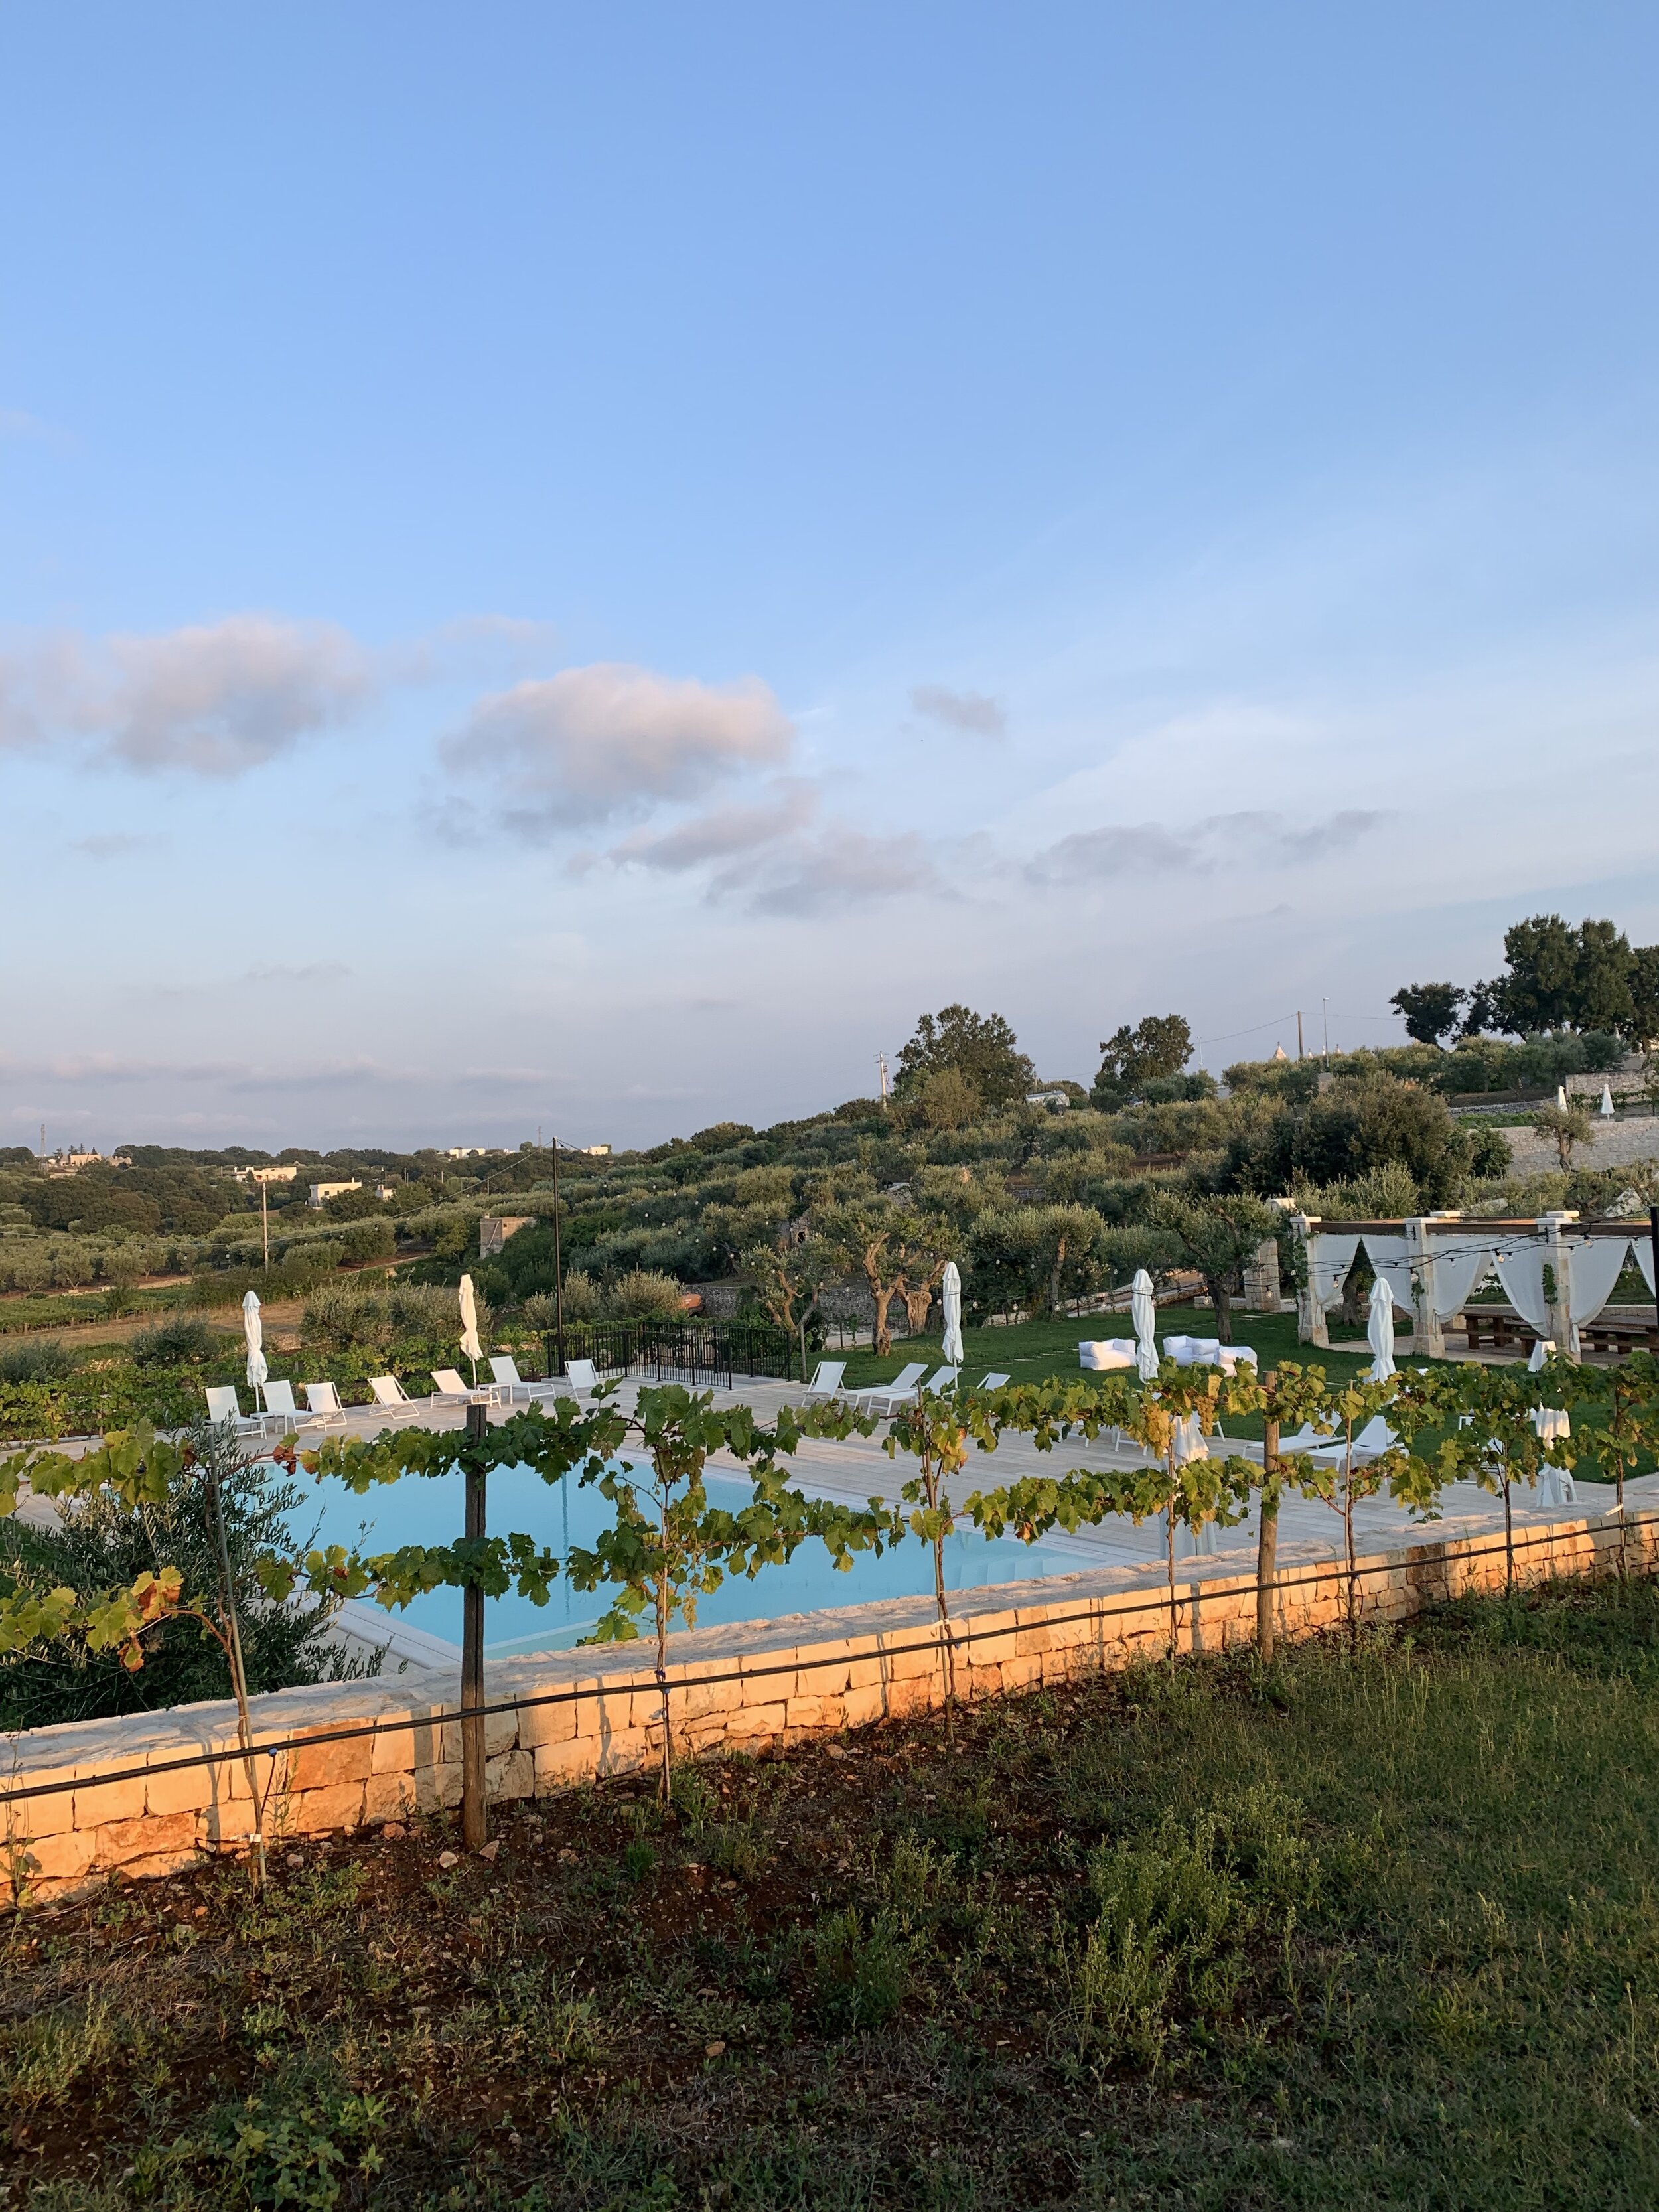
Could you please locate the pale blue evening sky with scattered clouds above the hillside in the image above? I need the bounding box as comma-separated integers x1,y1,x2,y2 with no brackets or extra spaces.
0,5,1659,1145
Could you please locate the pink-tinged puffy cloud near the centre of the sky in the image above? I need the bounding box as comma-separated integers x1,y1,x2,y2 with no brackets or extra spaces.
443,662,794,838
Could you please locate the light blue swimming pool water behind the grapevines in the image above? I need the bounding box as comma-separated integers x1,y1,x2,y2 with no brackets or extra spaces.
294,1467,1097,1657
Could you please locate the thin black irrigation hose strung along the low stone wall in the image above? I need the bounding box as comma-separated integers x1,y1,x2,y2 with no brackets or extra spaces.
0,1513,1659,1805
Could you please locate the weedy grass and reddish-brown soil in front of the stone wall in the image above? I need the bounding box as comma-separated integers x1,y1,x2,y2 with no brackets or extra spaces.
0,1584,1659,2212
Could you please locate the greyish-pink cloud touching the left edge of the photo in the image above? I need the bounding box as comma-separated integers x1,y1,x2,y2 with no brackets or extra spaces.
0,615,374,778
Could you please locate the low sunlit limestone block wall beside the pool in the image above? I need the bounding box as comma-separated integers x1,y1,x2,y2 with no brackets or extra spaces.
0,1513,1659,1907
